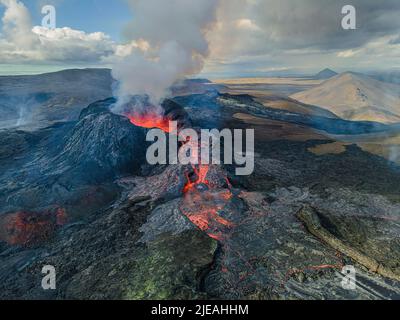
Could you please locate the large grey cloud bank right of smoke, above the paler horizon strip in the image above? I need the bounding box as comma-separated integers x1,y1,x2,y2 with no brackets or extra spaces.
209,0,400,53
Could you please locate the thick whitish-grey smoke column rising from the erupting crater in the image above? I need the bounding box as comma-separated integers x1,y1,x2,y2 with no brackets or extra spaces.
113,0,219,104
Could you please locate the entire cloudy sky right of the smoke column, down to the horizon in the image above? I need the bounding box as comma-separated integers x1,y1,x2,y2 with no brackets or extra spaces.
207,0,400,73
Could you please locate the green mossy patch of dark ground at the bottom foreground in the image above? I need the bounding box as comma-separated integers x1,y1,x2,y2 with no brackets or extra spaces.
125,230,217,300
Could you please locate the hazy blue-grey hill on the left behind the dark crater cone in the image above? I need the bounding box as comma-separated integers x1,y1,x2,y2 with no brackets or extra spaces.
0,69,113,129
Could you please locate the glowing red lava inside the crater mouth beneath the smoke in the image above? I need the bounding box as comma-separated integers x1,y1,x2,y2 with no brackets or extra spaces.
126,110,170,133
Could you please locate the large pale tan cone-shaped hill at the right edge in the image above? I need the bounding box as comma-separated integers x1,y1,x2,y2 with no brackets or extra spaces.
291,72,400,123
